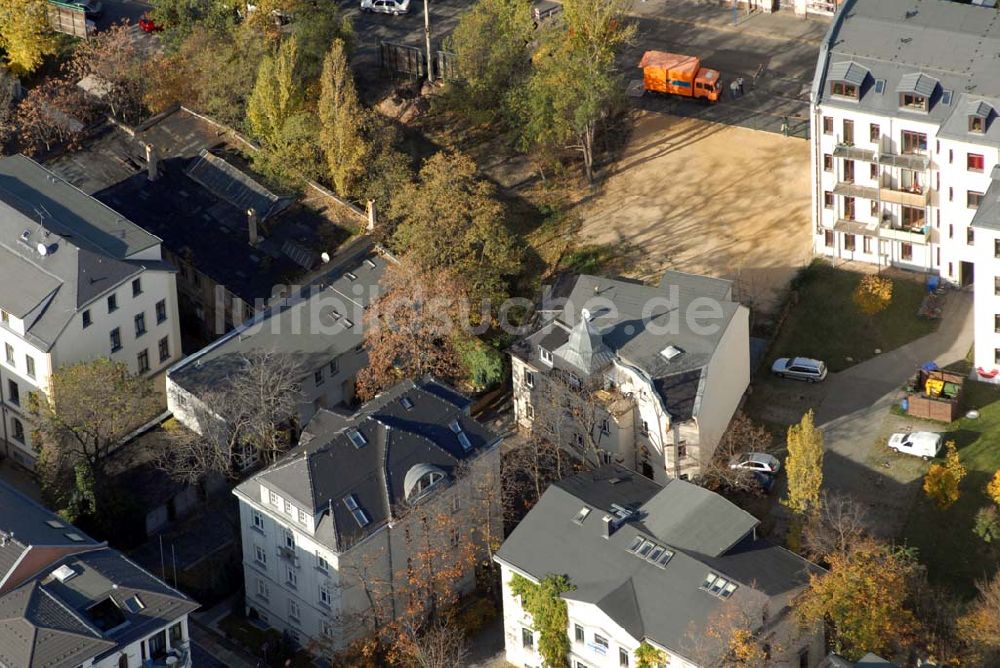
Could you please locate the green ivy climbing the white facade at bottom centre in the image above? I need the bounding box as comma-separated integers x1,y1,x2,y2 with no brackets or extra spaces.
510,573,576,667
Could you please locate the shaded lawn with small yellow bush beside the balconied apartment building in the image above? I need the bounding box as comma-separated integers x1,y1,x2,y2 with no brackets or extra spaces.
771,261,937,371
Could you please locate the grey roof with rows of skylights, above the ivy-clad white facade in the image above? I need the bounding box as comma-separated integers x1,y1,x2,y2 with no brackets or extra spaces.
497,465,819,656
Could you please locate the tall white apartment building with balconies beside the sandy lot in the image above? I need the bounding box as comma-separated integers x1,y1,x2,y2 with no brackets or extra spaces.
811,0,1000,377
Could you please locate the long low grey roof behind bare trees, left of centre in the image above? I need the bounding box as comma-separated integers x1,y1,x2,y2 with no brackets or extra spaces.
168,239,392,396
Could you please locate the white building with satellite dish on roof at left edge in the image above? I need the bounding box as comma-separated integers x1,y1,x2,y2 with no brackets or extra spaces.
0,155,181,467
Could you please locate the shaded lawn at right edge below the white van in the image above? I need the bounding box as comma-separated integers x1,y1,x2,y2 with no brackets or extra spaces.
904,381,1000,597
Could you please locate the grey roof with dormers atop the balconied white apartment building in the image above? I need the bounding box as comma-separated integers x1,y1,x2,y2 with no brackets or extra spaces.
813,0,1000,146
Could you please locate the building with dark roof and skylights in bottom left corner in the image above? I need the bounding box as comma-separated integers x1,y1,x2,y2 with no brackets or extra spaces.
0,482,198,668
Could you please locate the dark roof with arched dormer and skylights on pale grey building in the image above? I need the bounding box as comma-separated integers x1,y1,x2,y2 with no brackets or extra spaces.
237,378,500,552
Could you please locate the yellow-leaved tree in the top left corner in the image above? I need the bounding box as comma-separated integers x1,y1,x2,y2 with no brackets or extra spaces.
0,0,59,74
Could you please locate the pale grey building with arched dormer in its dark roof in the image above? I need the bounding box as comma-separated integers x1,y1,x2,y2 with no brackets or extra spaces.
234,378,502,656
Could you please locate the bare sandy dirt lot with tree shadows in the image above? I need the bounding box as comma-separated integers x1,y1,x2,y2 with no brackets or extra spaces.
576,114,811,312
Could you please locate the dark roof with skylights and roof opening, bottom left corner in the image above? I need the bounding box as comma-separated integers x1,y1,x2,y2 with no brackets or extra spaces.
0,482,198,668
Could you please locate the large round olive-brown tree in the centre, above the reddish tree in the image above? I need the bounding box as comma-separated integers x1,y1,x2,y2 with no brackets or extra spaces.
393,152,521,304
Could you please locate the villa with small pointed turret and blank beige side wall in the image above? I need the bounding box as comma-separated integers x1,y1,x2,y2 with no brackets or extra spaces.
510,271,750,482
